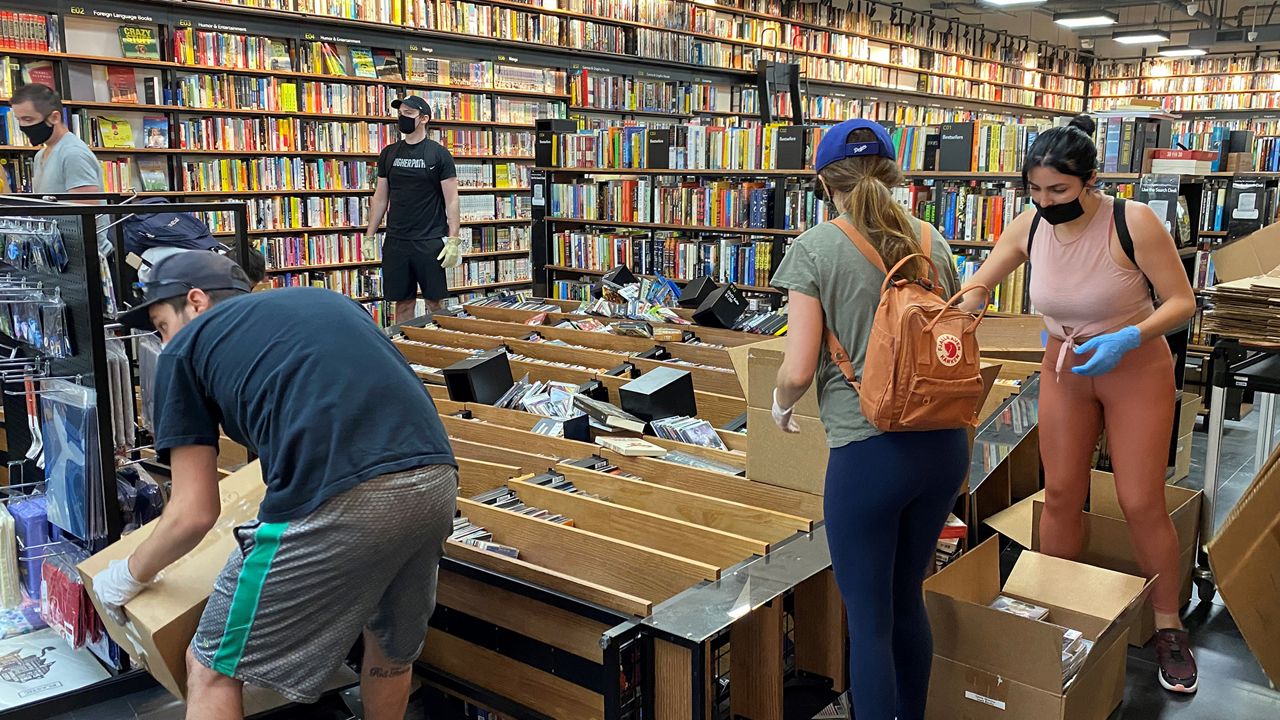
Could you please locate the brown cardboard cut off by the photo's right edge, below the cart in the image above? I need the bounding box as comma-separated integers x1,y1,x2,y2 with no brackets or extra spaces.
1208,448,1280,684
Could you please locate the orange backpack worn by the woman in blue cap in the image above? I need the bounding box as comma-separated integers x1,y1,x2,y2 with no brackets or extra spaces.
824,218,991,432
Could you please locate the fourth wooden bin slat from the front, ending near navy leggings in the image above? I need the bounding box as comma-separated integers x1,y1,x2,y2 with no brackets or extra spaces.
556,465,812,543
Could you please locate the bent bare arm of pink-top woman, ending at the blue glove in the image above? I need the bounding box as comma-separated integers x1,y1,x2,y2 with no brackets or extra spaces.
1125,202,1196,341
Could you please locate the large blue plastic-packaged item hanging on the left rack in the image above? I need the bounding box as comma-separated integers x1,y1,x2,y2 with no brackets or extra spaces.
40,379,106,542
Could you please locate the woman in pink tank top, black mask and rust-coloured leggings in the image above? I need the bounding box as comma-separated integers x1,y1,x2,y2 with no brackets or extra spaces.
965,115,1198,693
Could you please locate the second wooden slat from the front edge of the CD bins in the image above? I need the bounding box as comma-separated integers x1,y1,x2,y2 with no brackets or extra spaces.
458,498,719,601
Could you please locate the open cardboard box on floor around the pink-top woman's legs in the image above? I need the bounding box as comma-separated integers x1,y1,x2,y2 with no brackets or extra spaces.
987,470,1202,647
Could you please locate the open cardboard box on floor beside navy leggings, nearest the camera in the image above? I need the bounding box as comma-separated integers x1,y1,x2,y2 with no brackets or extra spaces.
924,538,1151,720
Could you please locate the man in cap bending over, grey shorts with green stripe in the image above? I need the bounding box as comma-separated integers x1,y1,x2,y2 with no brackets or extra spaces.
91,251,457,720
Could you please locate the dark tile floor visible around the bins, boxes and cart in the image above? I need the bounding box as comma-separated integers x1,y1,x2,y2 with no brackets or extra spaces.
49,418,1280,720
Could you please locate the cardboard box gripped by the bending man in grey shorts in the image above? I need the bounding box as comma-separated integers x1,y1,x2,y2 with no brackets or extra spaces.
79,462,266,697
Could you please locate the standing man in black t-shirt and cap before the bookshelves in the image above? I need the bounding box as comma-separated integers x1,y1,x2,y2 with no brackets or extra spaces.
366,95,462,323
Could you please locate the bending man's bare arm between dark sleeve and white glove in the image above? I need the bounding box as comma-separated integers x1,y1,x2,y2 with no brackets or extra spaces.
129,445,221,583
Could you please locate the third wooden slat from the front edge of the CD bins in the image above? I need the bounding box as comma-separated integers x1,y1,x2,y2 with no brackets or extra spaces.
507,480,769,570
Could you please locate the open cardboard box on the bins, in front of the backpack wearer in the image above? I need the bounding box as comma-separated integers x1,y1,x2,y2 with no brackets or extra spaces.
728,337,1001,495
